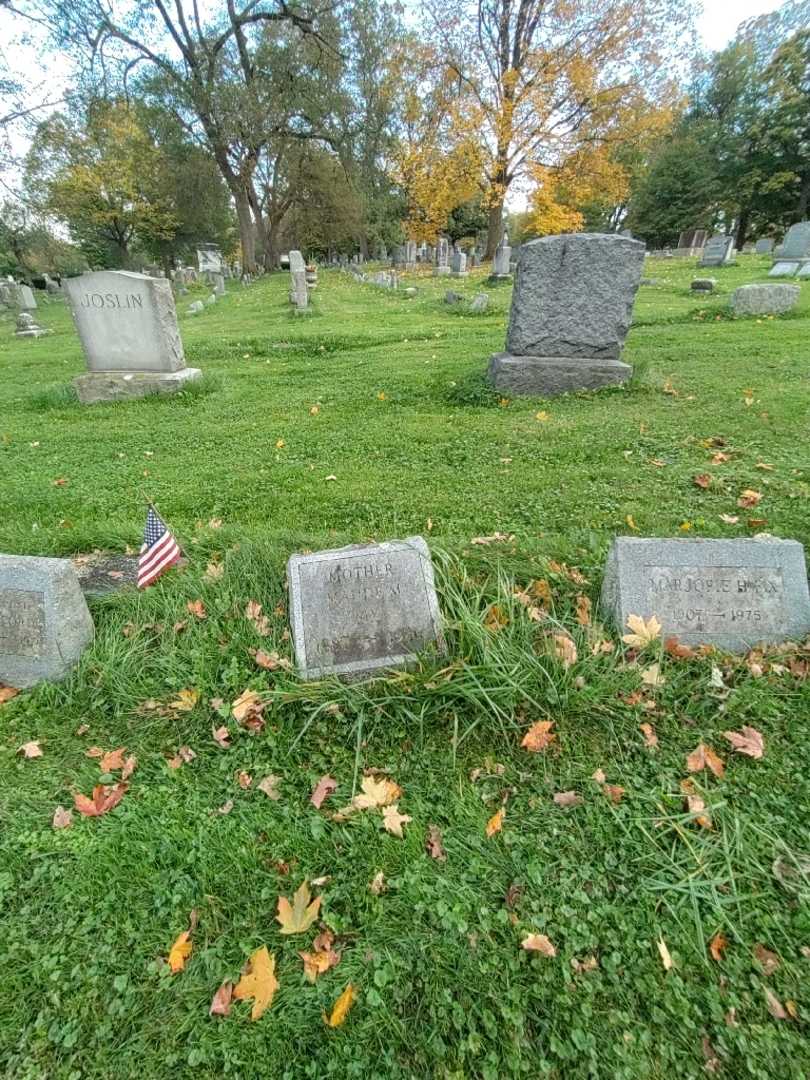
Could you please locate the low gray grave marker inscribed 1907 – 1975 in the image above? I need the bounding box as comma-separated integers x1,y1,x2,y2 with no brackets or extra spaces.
602,537,810,652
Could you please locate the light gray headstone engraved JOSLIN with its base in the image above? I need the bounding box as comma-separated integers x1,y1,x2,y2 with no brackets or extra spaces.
65,270,201,405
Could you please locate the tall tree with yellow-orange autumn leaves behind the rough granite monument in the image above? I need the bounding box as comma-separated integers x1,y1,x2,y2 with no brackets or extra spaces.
426,0,693,257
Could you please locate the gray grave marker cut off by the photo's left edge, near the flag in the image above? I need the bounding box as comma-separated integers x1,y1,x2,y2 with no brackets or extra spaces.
0,555,93,690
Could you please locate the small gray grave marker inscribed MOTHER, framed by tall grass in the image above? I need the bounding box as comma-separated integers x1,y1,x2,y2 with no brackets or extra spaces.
287,537,444,679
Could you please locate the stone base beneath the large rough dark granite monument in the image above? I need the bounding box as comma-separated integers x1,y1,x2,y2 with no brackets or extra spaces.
489,352,633,397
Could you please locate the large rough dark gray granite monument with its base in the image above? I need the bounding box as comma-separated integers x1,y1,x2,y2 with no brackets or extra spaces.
489,233,645,397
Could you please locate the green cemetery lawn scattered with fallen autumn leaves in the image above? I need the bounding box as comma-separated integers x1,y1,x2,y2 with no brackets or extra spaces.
0,256,810,1080
